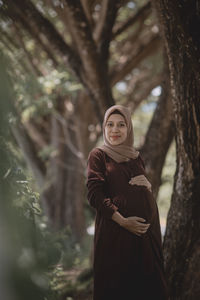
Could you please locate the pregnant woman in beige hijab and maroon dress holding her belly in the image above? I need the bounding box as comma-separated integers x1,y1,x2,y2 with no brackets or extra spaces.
87,105,168,300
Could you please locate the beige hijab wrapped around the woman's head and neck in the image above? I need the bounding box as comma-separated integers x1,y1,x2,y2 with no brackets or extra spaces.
98,105,139,163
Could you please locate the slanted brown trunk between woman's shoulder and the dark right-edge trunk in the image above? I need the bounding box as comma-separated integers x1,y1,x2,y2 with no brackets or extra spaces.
140,54,174,198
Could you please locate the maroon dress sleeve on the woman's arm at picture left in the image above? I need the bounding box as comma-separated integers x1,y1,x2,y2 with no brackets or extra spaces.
86,148,118,218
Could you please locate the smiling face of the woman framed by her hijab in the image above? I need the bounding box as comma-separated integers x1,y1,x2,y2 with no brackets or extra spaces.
105,114,127,145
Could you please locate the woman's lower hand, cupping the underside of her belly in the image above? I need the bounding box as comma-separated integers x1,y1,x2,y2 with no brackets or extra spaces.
122,216,150,236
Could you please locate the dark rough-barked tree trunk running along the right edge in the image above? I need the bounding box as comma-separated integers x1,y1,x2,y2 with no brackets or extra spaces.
152,0,200,299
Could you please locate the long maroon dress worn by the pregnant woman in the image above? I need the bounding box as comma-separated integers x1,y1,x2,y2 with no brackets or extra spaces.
87,148,168,300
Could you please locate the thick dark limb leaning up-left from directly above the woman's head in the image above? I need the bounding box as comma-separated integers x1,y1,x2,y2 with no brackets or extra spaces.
66,0,114,121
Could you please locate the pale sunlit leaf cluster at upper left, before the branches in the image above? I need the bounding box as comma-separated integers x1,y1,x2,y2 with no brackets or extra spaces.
11,69,82,122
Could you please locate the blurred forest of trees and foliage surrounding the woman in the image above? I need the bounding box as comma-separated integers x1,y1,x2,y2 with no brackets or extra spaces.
0,0,200,300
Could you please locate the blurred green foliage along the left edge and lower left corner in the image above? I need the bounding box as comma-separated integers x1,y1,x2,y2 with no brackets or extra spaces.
0,52,88,300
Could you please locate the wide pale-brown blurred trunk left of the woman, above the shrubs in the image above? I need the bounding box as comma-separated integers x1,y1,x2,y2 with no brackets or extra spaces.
42,115,85,241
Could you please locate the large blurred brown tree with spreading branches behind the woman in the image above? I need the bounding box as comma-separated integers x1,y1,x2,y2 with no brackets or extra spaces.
0,0,173,239
